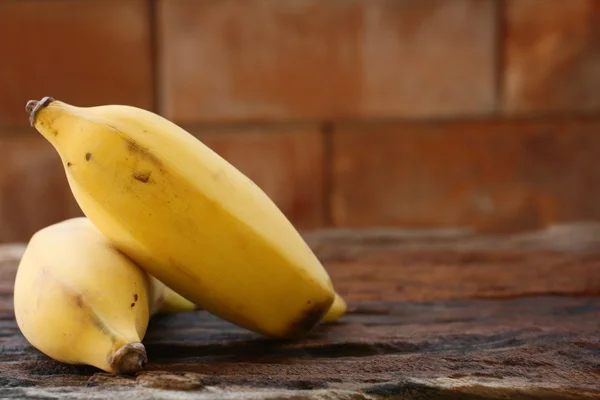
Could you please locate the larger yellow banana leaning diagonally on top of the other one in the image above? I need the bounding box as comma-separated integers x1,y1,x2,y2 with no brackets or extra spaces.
26,97,335,338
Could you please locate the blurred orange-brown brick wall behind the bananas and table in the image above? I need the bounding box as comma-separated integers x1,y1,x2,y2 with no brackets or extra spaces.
0,0,600,242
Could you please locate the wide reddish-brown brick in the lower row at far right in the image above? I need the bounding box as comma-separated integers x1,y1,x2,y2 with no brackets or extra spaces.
331,120,600,231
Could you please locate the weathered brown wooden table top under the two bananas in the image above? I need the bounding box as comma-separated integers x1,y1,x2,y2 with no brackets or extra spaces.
0,224,600,399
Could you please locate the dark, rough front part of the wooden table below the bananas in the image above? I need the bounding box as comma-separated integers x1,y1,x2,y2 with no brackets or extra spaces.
0,297,600,400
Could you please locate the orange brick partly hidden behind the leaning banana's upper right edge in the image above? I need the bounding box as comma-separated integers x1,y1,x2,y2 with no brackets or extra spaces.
192,126,324,229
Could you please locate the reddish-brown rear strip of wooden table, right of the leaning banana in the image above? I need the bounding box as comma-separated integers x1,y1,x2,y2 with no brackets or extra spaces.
307,223,600,302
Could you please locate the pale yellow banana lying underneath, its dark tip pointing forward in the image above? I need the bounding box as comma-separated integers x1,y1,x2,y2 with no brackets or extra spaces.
14,218,190,374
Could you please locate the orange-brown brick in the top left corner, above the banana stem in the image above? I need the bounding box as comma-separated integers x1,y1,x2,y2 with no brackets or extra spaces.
0,0,153,126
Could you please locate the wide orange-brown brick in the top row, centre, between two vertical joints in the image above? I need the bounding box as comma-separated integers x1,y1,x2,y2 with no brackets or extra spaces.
158,0,496,123
